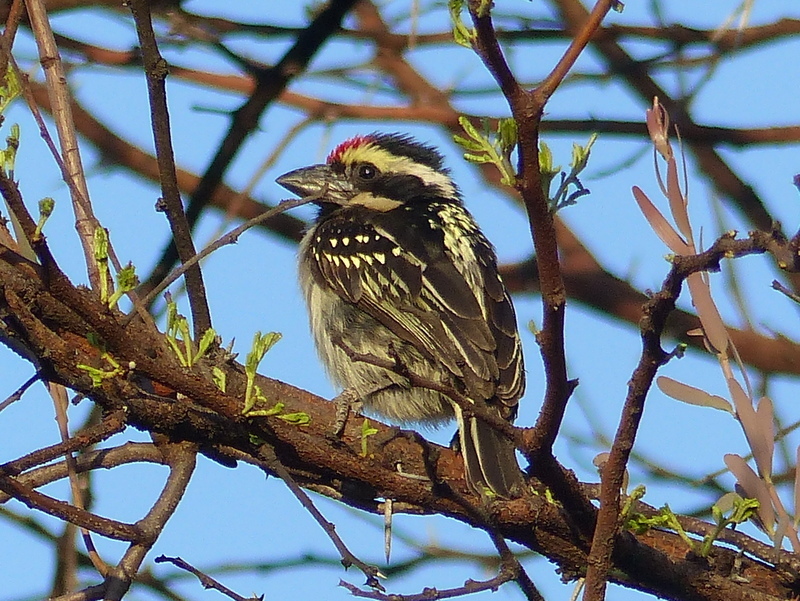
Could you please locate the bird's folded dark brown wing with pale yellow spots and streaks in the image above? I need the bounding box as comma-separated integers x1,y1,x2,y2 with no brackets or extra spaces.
314,205,524,407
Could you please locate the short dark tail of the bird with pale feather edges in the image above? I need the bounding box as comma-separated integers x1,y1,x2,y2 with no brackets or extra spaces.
453,403,525,499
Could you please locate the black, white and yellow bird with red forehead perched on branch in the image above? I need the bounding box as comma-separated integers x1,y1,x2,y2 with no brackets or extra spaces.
277,133,525,498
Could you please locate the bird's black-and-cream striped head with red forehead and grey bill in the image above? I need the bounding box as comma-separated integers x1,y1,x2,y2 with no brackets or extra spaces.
277,133,460,212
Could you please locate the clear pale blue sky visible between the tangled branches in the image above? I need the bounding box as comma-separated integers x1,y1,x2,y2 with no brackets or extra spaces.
0,0,800,601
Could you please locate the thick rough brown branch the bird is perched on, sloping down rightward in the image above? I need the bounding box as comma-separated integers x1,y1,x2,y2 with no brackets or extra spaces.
0,232,800,601
